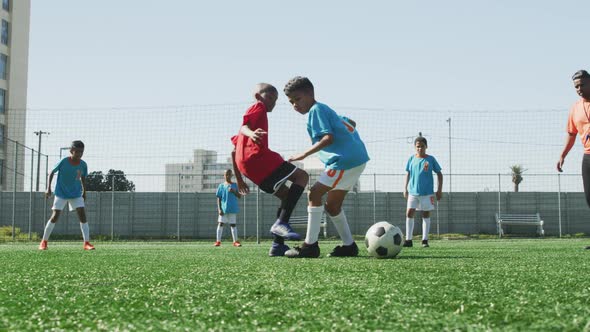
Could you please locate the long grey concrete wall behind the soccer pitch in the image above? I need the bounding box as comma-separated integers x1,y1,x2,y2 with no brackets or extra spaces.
0,192,590,239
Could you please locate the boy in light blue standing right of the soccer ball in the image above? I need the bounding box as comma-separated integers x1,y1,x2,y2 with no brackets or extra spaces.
404,136,443,247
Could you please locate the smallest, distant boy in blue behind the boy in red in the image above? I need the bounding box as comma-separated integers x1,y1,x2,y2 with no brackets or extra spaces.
214,169,242,247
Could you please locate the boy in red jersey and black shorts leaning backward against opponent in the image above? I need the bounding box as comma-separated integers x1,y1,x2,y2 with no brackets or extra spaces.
232,83,309,256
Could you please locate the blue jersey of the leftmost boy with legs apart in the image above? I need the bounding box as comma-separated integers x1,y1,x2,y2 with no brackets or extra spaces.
53,157,88,198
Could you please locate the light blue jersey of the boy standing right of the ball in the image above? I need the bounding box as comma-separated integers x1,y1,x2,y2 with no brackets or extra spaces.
406,155,441,196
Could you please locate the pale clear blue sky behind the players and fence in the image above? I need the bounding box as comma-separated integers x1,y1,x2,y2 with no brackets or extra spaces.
27,0,590,190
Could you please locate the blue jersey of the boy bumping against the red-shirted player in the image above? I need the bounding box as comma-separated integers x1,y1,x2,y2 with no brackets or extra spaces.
307,102,369,170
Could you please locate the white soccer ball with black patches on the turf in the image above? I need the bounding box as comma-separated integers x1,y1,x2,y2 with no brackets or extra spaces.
365,221,403,258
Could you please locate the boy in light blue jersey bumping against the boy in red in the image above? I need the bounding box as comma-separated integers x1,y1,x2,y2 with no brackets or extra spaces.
284,76,369,258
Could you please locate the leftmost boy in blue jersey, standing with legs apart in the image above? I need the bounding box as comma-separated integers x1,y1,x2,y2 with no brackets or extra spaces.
39,141,94,250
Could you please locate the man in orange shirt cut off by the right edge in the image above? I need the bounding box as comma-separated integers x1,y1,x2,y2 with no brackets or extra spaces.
557,70,590,249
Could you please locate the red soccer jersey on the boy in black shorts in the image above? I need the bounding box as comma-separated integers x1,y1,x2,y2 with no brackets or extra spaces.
231,102,285,185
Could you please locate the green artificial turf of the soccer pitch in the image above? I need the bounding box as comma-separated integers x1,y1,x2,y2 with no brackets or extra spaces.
0,239,590,331
